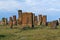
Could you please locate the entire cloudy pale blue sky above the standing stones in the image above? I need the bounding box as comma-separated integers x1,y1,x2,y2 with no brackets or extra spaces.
0,0,60,21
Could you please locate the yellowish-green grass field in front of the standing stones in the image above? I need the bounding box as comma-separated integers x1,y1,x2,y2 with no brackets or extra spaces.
0,26,60,40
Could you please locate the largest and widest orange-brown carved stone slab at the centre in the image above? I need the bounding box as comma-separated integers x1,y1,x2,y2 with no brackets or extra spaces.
22,12,34,28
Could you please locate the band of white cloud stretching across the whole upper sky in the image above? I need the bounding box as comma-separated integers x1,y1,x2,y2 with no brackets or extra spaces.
0,0,60,12
